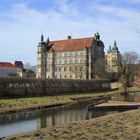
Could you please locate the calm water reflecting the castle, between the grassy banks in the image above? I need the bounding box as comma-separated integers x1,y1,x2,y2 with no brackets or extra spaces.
0,93,140,137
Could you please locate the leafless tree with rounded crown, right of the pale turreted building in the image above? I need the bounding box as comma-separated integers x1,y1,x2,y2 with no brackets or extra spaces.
120,51,139,92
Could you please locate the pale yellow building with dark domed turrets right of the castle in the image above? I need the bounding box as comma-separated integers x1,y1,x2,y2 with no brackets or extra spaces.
106,41,122,73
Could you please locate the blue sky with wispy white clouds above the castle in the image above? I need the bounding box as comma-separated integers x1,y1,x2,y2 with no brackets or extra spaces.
0,0,140,65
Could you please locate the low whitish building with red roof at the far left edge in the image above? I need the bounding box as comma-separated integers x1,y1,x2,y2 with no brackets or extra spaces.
0,62,22,77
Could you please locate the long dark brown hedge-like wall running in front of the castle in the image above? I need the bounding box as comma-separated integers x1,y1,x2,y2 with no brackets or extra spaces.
0,78,110,97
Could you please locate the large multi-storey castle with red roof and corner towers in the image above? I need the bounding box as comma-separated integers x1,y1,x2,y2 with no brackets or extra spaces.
36,33,122,79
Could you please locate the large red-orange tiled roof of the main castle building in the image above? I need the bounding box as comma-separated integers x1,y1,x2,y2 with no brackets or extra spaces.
49,37,94,51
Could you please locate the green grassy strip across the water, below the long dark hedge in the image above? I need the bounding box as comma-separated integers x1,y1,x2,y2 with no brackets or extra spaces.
0,87,140,114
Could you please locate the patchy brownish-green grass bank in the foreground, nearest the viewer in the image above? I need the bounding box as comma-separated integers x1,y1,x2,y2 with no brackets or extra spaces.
4,110,140,140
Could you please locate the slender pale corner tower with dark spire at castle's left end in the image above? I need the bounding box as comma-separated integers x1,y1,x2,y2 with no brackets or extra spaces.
36,34,47,78
